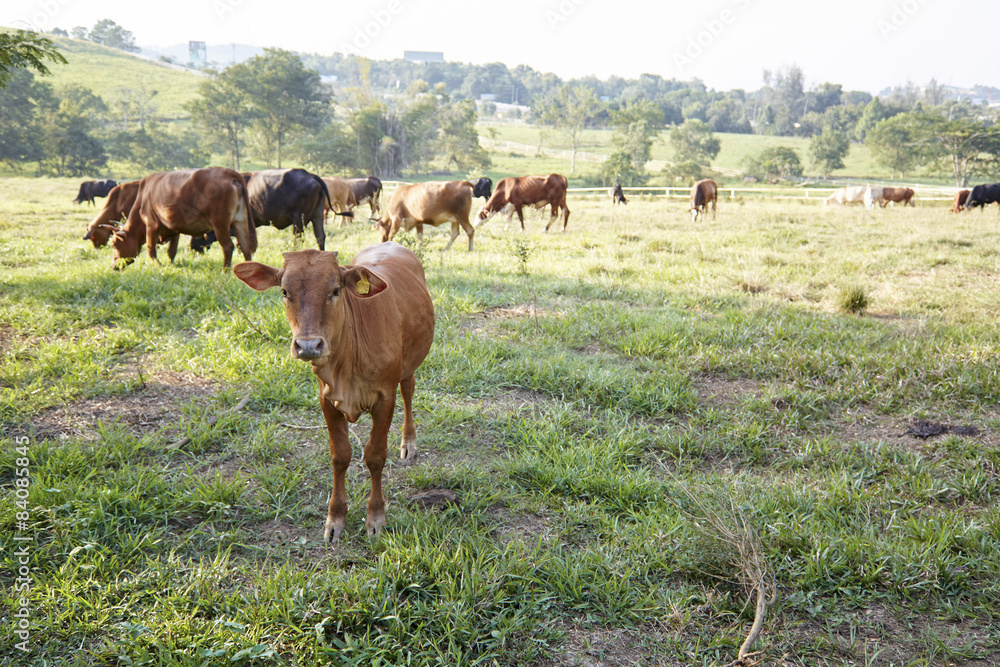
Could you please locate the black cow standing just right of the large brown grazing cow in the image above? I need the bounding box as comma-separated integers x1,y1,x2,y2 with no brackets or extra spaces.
247,169,330,250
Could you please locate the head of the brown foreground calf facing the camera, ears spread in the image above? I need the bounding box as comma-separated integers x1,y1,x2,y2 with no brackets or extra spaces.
233,249,388,365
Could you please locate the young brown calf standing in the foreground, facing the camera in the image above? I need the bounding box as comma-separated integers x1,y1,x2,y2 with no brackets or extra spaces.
233,243,434,543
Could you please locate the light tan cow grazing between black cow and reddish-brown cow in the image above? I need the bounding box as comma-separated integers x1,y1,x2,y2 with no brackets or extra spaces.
378,181,475,251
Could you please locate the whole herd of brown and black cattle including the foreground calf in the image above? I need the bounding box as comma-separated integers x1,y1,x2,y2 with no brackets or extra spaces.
70,167,1000,543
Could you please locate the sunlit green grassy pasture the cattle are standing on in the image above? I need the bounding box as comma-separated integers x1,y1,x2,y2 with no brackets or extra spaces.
0,179,1000,666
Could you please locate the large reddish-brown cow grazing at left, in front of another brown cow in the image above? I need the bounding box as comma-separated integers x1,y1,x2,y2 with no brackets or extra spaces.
111,167,257,268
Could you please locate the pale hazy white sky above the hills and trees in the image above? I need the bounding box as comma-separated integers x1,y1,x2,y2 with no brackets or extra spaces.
0,0,1000,93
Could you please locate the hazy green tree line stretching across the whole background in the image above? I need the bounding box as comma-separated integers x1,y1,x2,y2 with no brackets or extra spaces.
0,26,1000,185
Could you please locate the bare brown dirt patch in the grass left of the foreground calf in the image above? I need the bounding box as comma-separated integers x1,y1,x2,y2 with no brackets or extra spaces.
32,371,218,440
